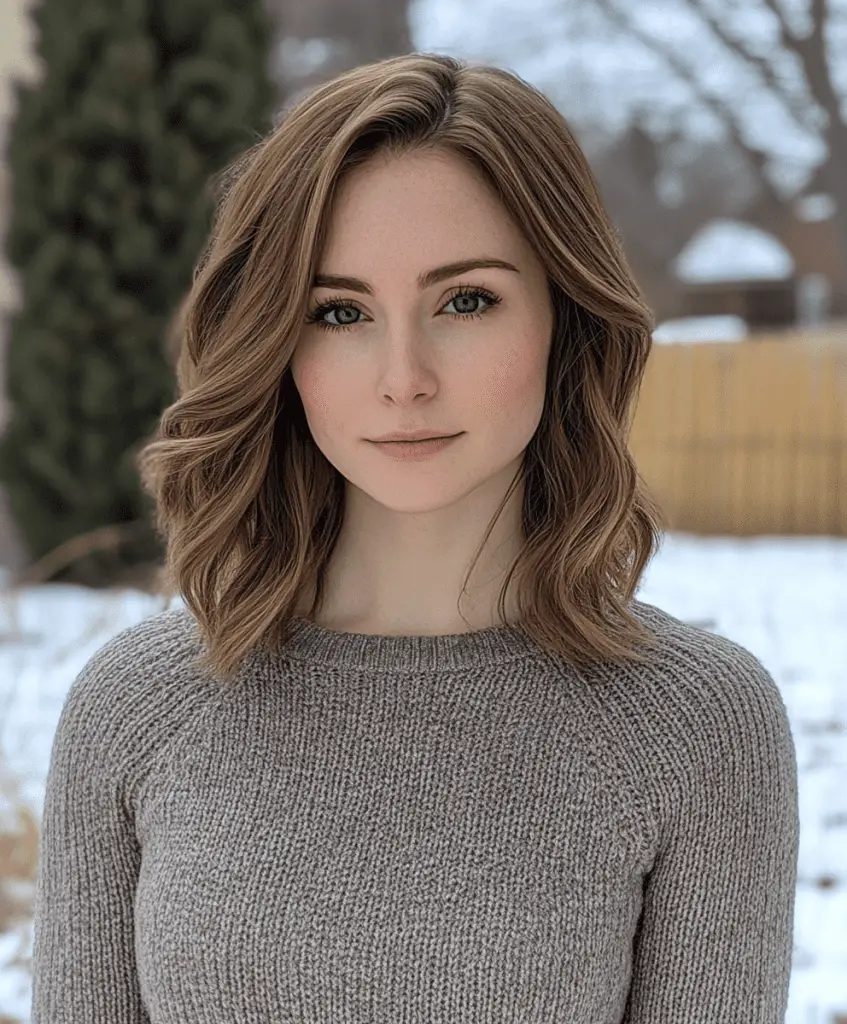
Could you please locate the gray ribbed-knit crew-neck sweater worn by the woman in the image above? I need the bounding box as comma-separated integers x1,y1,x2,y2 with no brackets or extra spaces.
32,601,799,1024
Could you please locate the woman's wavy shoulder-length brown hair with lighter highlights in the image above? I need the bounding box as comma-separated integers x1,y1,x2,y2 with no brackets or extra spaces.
136,53,665,681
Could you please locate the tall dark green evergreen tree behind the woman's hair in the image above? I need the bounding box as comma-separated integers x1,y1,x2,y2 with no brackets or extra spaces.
0,0,274,584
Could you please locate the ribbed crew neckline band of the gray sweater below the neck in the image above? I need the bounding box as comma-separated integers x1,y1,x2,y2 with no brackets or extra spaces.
281,615,541,672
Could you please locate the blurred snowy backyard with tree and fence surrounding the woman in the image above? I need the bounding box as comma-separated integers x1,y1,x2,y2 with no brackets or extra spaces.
0,0,847,1024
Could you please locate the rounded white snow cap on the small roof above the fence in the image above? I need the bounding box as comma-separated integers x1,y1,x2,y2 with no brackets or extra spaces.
674,219,795,284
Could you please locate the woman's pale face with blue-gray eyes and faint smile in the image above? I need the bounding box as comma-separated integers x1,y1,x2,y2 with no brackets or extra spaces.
291,152,554,512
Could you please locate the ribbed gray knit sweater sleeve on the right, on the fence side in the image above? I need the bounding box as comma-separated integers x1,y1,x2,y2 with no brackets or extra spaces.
622,647,800,1024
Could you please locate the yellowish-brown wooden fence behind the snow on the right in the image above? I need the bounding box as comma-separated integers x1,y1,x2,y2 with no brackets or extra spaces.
630,330,847,537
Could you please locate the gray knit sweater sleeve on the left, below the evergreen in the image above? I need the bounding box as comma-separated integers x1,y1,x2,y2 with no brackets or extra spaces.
31,641,149,1024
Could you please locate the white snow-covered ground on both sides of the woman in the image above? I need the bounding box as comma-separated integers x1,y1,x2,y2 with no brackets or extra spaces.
0,534,847,1024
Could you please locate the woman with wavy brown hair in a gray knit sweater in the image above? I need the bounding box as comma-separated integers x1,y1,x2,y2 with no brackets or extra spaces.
33,53,798,1024
